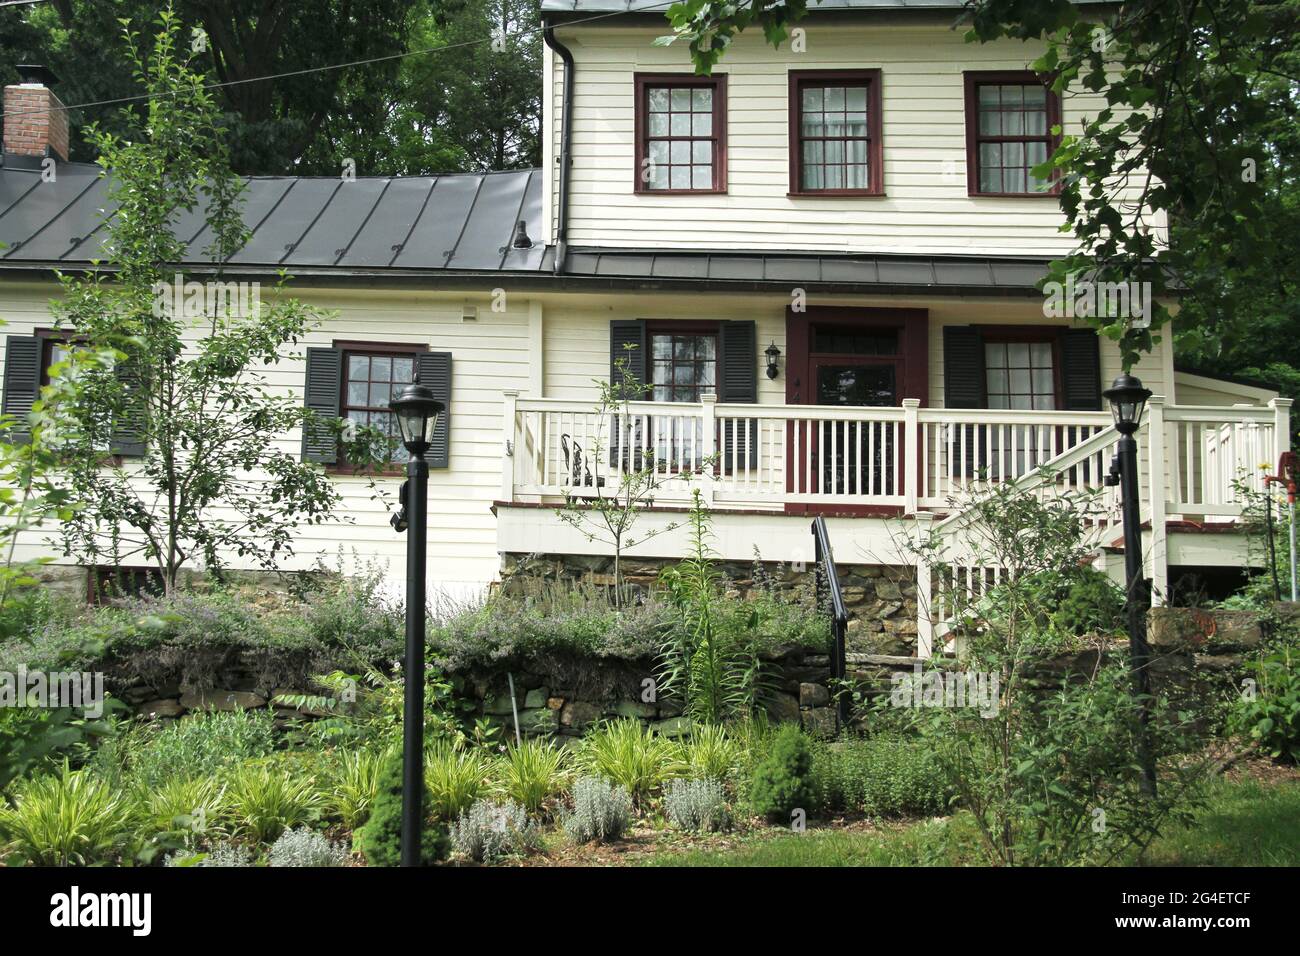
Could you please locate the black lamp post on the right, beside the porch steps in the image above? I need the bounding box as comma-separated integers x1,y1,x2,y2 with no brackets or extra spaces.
1101,373,1156,796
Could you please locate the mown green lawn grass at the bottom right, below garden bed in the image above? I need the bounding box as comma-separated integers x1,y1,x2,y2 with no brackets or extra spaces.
640,779,1300,866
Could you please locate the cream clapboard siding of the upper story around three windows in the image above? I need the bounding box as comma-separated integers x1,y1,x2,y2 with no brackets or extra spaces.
543,25,1162,256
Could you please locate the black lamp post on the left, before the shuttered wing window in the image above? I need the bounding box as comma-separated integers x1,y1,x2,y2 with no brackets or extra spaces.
389,378,442,866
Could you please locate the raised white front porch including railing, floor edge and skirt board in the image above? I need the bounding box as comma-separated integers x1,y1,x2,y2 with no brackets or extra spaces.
497,393,1291,657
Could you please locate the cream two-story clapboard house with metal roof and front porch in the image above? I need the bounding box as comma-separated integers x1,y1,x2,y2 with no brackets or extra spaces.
0,0,1290,653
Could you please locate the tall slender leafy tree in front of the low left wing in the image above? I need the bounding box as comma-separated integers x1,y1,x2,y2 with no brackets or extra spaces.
55,8,384,593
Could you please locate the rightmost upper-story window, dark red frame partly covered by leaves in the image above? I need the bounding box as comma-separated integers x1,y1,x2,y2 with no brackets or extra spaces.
966,72,1061,196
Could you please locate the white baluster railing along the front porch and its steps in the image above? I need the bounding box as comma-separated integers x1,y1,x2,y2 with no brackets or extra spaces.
501,393,1291,656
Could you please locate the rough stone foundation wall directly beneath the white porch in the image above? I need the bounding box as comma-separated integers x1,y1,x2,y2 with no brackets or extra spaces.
501,554,917,656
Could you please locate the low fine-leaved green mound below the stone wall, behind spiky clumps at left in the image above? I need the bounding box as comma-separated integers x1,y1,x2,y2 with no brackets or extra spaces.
129,709,276,788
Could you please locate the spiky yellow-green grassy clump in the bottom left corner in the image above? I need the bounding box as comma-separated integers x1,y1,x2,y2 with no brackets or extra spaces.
0,761,135,866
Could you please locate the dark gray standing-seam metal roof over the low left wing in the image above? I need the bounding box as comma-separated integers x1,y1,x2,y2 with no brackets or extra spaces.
0,163,546,273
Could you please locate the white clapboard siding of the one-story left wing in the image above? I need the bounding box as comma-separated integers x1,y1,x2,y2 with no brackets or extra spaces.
0,282,530,593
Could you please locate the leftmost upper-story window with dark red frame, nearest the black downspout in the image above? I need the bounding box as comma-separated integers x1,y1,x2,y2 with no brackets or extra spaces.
636,73,727,193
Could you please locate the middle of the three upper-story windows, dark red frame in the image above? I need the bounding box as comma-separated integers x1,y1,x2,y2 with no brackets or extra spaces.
789,70,884,196
